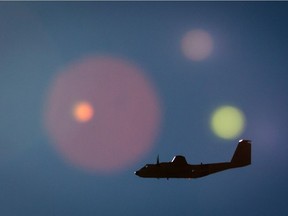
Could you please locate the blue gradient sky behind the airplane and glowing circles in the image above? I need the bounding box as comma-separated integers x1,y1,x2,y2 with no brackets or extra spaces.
0,2,288,216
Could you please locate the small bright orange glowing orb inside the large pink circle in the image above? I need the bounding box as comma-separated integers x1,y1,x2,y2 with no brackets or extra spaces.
73,102,94,123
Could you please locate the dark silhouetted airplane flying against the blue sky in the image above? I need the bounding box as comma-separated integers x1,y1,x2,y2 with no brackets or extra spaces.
135,140,251,179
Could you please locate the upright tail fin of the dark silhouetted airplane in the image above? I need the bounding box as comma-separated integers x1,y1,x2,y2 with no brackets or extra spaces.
231,140,251,167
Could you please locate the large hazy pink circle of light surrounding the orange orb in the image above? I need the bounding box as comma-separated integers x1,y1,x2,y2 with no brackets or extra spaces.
44,56,161,173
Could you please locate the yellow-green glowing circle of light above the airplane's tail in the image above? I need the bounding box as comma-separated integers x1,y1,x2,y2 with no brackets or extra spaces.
210,106,245,139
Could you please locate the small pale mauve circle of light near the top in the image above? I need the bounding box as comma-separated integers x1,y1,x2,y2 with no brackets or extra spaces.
181,29,213,61
